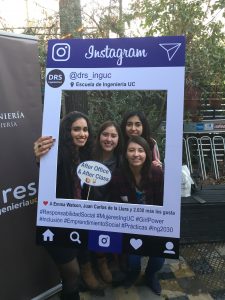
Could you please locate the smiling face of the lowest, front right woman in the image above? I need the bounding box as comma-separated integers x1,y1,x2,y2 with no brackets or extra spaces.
126,142,146,168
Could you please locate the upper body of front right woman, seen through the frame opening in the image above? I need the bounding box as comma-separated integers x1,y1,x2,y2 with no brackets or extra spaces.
110,136,163,205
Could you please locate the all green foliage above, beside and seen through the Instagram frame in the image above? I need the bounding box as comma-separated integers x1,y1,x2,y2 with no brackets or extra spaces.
16,0,225,125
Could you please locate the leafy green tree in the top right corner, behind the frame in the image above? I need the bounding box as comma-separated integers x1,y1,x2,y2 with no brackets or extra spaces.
127,0,225,116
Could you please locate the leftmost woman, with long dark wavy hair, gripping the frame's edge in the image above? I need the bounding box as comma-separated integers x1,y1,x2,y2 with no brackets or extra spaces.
34,111,102,300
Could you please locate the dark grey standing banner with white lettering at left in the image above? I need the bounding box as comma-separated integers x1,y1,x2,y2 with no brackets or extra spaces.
0,32,59,300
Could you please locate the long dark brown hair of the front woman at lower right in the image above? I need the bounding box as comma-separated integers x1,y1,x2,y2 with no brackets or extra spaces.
122,136,152,189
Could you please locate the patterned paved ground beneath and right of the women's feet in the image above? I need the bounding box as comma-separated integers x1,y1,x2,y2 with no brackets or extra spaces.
49,243,225,300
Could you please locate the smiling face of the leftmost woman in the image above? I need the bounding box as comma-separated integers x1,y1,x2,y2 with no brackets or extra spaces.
71,118,89,147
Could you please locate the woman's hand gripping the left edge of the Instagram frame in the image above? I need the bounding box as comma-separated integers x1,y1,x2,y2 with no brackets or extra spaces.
34,136,55,162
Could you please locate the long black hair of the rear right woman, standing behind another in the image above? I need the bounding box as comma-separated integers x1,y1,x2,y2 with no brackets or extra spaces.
120,111,155,150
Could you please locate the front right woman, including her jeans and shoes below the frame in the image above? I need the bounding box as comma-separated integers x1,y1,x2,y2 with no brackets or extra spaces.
110,136,164,295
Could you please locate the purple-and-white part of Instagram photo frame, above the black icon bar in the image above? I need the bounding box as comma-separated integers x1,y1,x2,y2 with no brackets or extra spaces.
37,36,185,251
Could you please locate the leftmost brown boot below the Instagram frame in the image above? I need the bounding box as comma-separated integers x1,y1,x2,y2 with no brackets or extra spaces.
80,262,104,290
